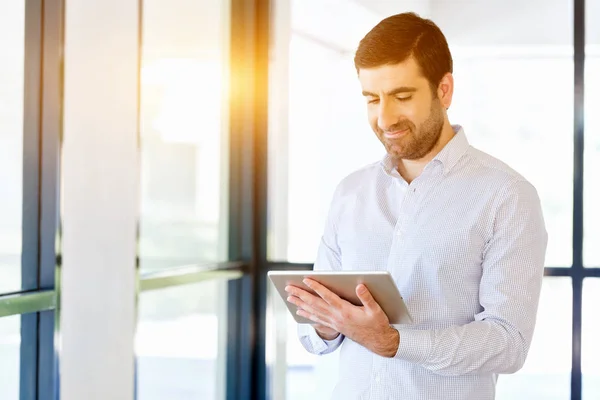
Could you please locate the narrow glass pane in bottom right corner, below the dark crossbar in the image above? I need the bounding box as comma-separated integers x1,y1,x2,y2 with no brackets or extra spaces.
581,278,600,400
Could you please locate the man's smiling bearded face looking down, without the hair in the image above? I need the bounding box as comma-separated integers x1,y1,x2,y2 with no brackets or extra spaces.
359,57,445,160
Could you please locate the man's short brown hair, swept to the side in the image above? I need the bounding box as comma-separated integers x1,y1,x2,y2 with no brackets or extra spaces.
354,12,452,90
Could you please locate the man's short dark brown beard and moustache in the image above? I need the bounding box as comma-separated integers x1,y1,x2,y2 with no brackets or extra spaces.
375,99,444,160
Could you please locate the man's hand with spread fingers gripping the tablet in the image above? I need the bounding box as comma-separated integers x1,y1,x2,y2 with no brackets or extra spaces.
285,278,400,357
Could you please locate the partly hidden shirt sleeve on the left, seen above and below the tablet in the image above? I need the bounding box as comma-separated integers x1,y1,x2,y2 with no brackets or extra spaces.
298,189,344,354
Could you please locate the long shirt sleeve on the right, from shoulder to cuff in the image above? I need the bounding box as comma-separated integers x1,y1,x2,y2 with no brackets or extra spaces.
395,181,548,375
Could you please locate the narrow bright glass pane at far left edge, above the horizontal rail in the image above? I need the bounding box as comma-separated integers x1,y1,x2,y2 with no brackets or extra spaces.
0,1,25,293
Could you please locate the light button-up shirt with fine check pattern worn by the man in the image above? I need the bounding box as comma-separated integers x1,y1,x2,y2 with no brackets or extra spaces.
298,125,547,400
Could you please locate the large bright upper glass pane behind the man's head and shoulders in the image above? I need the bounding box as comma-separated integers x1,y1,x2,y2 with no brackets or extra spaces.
269,0,573,266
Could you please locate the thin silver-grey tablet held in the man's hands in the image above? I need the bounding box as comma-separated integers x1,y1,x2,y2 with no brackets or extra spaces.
268,271,412,325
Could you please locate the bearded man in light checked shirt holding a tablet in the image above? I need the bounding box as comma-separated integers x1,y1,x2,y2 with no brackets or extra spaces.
286,13,547,400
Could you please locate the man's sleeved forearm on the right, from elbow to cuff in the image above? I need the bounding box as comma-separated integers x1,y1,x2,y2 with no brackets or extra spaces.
395,319,529,375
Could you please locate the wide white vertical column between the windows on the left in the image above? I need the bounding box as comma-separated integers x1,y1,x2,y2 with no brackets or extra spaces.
59,0,139,400
